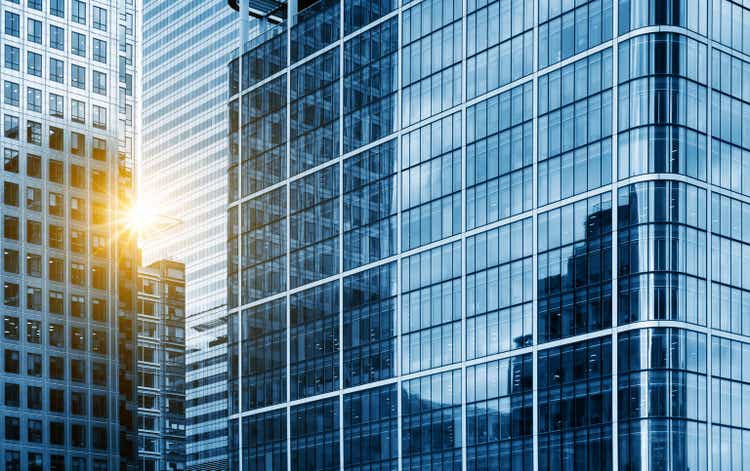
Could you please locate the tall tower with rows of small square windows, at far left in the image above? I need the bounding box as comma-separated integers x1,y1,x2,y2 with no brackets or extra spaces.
0,0,138,470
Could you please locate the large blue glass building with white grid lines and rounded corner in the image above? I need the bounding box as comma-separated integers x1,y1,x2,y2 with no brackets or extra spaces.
228,0,750,471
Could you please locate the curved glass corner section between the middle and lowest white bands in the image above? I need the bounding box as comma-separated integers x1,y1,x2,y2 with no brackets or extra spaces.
617,180,707,326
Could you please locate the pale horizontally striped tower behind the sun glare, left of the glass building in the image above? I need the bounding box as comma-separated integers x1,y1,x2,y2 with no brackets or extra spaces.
139,0,244,471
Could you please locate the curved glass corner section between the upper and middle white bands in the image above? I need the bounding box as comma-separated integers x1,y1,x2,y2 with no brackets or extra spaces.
617,33,707,181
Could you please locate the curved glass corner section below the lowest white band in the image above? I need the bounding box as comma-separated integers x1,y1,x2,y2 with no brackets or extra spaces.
617,328,708,470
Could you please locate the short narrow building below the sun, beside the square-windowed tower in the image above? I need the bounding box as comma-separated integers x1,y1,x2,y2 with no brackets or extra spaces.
138,260,186,471
